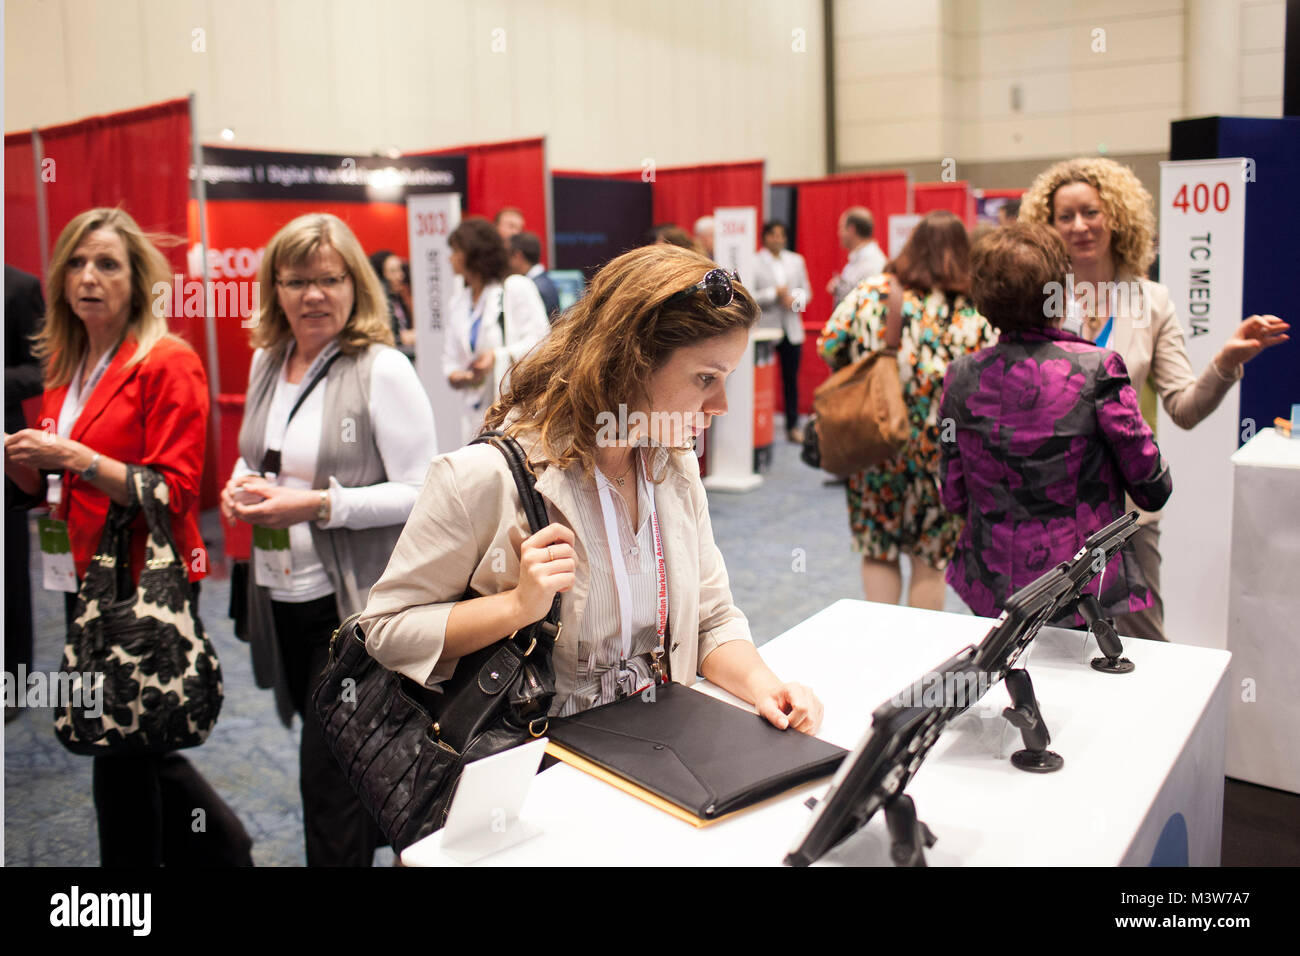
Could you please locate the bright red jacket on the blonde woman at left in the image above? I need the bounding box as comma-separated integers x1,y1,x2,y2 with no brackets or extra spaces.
36,336,209,581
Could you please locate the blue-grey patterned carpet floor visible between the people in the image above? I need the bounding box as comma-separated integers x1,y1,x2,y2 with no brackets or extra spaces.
4,431,967,866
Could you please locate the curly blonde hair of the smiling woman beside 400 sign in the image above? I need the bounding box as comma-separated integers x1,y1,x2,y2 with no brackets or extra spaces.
1021,156,1156,277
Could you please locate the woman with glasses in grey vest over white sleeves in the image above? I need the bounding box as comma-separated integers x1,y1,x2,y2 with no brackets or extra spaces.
221,213,439,866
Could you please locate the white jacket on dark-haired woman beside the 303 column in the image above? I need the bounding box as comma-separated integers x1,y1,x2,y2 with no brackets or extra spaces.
442,276,551,442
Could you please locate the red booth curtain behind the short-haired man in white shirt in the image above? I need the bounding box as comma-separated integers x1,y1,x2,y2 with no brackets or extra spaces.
775,172,907,414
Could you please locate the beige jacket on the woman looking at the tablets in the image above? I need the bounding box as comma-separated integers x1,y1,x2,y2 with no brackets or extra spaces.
361,429,753,706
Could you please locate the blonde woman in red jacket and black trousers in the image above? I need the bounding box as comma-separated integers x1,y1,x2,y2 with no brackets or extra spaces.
5,208,252,866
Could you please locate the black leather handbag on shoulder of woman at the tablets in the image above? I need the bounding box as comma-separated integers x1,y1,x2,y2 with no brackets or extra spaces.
312,432,560,853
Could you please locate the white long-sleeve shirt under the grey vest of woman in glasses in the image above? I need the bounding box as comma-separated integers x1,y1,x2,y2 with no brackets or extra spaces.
234,349,438,604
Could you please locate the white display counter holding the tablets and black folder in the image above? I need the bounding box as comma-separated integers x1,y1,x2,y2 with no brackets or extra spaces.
402,601,1229,866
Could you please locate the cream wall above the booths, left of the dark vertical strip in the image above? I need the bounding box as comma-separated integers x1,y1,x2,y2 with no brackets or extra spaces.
4,0,826,178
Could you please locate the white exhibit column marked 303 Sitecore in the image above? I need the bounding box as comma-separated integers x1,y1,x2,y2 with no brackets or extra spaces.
407,193,463,454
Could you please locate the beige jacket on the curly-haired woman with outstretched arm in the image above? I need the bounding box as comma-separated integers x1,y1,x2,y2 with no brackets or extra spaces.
1108,274,1242,524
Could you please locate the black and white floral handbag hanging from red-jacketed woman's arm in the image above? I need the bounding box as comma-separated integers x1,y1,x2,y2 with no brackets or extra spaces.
55,466,222,756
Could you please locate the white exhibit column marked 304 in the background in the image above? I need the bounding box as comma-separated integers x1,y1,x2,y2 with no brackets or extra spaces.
705,206,763,492
